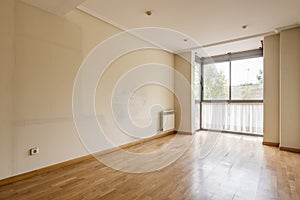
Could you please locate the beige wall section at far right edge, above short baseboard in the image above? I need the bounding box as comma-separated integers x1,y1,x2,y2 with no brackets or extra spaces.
280,28,300,149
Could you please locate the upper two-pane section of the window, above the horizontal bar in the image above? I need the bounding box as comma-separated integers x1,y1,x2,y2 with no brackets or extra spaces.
202,50,263,101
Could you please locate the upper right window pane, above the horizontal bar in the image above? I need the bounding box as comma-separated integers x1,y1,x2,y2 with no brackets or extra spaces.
231,57,263,100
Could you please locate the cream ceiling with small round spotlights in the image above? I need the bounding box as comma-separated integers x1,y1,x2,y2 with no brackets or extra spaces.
23,0,300,55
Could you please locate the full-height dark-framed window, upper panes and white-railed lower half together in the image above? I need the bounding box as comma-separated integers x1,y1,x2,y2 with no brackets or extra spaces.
196,49,263,135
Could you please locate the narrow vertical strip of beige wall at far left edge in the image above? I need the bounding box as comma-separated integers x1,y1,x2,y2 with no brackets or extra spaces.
0,0,15,179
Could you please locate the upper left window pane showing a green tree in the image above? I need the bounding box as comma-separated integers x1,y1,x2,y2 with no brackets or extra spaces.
203,62,229,100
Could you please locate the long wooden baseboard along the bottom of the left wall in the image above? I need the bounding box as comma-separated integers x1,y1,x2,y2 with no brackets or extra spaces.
0,131,175,186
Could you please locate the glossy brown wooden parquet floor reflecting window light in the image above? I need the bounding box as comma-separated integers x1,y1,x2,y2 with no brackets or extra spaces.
0,132,300,200
